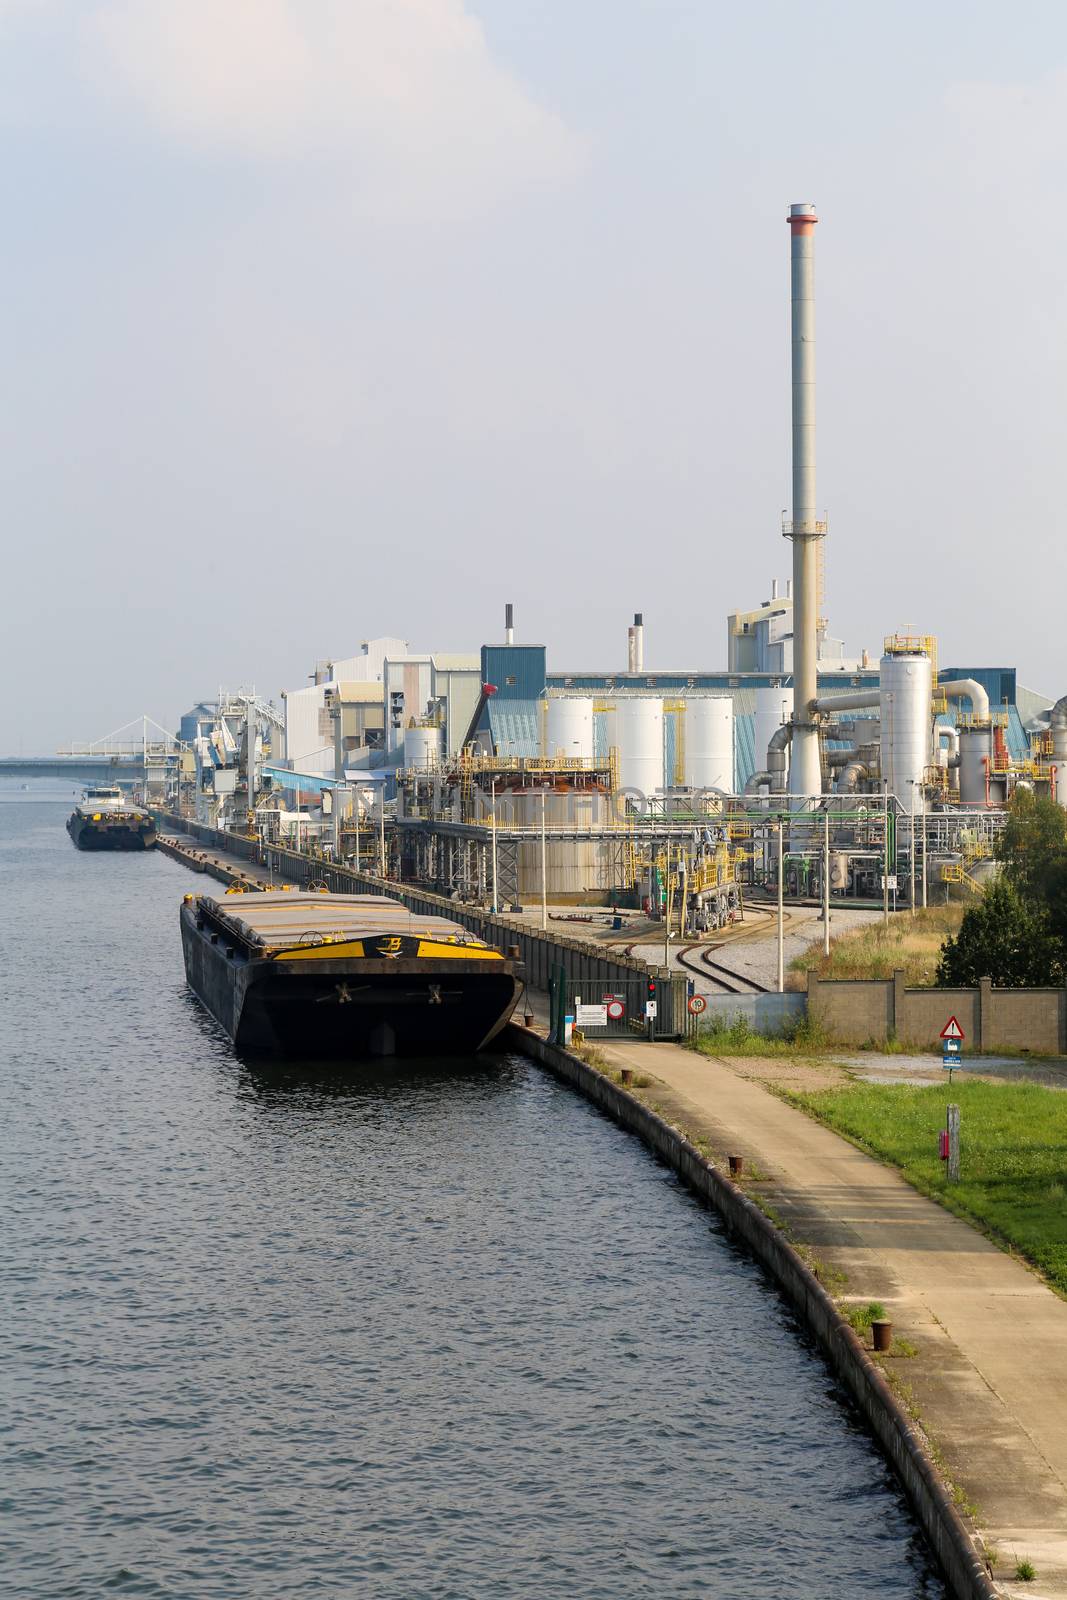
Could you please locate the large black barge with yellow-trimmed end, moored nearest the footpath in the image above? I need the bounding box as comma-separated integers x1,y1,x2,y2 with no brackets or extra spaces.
181,890,520,1059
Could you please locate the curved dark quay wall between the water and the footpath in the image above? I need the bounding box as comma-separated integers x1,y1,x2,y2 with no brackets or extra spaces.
502,1027,997,1600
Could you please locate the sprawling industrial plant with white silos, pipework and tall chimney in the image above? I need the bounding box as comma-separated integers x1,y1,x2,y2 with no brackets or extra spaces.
60,205,1067,938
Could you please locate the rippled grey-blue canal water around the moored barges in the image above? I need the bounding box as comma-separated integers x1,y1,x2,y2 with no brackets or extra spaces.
0,798,944,1600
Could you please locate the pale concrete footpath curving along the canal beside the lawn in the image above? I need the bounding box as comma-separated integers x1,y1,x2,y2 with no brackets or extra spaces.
597,1042,1067,1600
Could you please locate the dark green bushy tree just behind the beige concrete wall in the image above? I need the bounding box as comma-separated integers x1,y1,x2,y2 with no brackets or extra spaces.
937,875,1065,989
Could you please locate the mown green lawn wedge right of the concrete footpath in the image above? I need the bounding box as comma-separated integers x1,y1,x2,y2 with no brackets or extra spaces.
787,1082,1067,1296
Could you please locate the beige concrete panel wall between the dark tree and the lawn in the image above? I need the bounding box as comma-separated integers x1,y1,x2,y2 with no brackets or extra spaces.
808,971,1067,1056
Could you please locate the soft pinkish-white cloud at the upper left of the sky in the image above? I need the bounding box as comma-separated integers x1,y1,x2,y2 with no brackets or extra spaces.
91,0,585,211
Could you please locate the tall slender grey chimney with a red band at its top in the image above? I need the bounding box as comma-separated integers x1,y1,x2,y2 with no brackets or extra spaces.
787,205,825,795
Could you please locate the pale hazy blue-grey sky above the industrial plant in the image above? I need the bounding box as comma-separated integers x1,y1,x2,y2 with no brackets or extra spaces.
0,0,1067,755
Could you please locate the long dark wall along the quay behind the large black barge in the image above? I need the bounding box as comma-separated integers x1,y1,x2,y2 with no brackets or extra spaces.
157,811,691,1038
